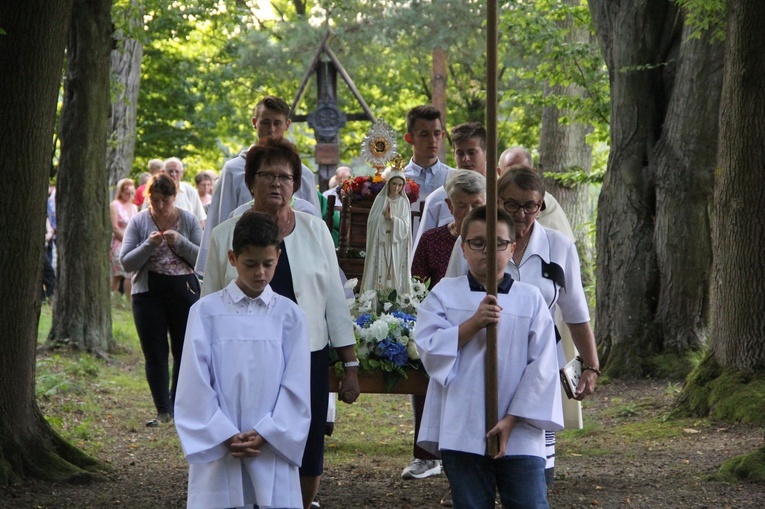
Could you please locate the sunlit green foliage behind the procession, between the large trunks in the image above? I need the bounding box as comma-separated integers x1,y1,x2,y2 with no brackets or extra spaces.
131,0,608,174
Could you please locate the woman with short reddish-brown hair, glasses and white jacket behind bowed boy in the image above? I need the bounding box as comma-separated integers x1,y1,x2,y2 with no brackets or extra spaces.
202,138,359,508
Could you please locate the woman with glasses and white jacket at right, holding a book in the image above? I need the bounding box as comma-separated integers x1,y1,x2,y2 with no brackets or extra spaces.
446,166,600,484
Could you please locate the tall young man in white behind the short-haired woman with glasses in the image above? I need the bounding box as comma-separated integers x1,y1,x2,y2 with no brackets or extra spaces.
195,95,321,275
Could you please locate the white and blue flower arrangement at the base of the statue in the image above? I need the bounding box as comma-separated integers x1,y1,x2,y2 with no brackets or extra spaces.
336,278,428,392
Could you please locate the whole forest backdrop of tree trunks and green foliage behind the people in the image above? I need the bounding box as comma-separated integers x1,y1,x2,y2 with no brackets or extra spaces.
0,0,765,492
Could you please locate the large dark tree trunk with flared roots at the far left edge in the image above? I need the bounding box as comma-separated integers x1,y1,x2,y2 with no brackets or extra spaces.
0,0,103,485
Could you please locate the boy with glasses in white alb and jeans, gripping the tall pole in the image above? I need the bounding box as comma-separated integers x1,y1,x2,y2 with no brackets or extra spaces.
415,207,563,508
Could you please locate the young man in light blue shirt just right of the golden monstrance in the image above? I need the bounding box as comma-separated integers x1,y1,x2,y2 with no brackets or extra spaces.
404,105,453,208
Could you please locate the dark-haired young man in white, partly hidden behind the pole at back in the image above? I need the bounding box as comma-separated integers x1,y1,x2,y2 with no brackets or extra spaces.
412,122,486,253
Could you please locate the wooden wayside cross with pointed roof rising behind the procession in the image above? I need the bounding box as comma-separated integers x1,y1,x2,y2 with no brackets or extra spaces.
290,29,375,191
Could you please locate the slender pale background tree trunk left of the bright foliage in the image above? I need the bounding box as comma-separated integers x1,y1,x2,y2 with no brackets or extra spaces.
106,0,143,197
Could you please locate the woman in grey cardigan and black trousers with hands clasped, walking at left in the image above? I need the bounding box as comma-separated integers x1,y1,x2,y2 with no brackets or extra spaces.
120,173,202,426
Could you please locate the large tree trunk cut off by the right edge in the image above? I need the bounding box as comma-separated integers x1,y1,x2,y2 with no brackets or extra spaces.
710,0,765,373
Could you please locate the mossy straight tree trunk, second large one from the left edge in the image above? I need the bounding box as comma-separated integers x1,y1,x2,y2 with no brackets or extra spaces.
48,0,113,354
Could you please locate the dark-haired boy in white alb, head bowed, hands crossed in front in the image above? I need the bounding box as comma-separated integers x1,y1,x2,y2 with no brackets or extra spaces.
175,212,311,509
